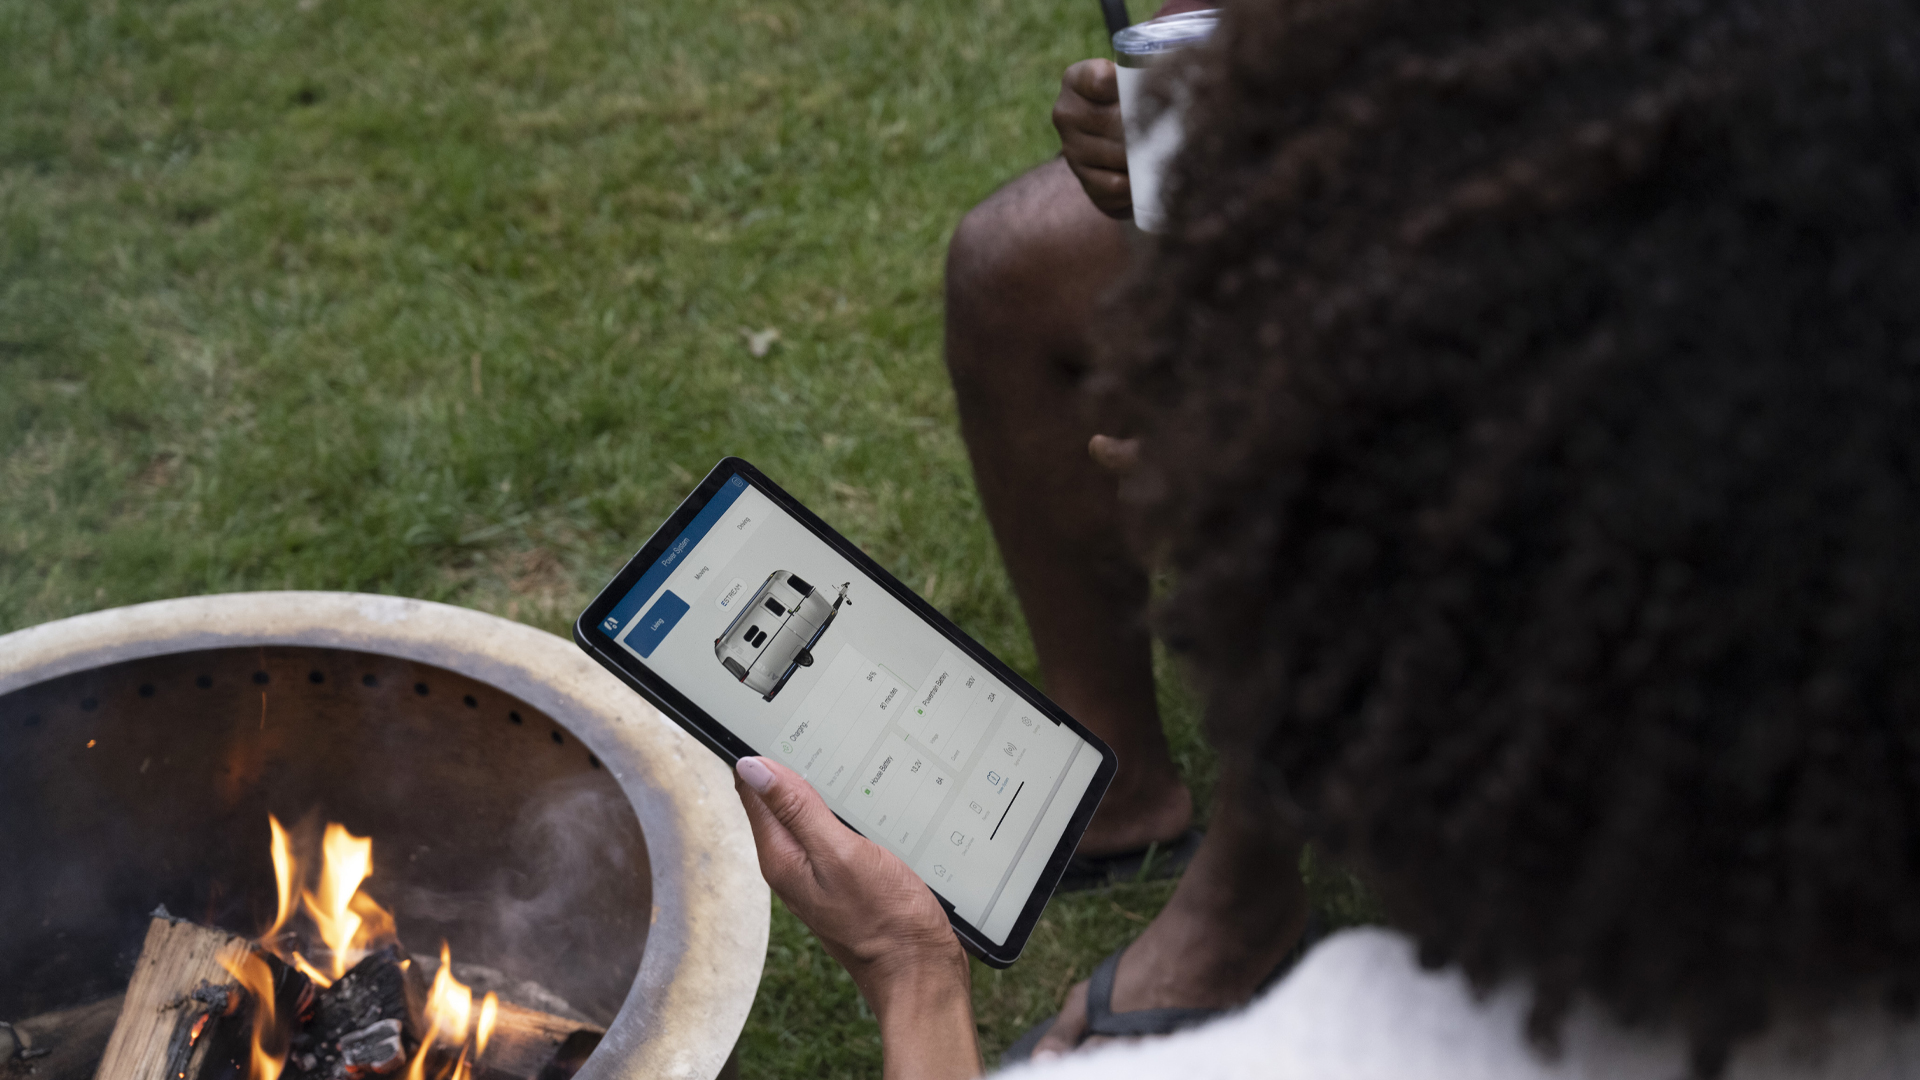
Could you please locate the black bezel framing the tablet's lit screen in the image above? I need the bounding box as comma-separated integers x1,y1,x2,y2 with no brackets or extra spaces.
574,457,1119,969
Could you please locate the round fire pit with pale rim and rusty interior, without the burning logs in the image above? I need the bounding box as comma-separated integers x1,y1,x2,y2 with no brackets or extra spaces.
0,592,768,1080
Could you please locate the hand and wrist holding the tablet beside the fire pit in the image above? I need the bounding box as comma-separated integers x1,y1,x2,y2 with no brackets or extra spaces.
733,757,979,1080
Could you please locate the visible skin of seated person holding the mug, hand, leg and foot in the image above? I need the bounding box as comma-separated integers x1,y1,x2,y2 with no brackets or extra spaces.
947,35,1306,1053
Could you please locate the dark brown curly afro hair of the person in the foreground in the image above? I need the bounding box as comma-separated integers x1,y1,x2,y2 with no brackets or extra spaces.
1100,0,1920,1076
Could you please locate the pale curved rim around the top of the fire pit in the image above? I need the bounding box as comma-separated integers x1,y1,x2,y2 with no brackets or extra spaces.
0,592,770,1080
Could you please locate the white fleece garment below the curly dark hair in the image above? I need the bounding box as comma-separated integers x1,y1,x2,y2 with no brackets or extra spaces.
996,930,1920,1080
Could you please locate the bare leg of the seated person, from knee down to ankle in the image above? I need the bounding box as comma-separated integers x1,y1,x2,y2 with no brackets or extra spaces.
947,160,1192,855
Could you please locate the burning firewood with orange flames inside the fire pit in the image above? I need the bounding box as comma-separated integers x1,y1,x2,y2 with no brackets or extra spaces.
82,817,605,1080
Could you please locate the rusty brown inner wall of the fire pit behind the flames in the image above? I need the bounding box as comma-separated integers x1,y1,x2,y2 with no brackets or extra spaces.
0,648,651,1024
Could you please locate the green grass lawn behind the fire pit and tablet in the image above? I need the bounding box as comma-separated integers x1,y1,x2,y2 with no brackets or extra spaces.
0,0,1374,1076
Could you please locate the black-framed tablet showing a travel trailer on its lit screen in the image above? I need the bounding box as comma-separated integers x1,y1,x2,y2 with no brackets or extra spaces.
574,457,1116,967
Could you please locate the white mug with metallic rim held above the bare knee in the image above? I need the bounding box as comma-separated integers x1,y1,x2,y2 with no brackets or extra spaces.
1114,12,1219,233
